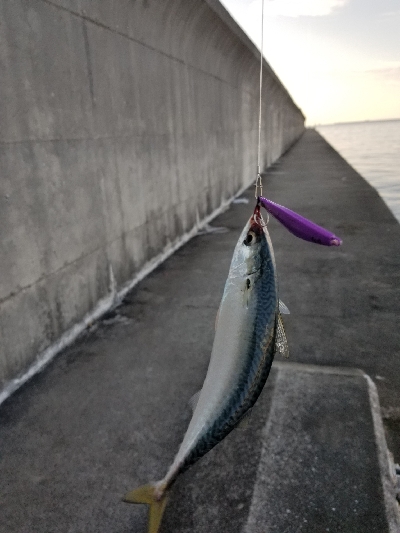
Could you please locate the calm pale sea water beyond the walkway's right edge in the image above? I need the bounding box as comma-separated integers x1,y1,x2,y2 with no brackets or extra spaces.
316,120,400,222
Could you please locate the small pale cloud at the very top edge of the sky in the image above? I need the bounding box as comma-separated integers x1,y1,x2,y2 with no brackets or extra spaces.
265,0,349,17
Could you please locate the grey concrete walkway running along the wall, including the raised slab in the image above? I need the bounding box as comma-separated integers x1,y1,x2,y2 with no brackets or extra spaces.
0,130,400,533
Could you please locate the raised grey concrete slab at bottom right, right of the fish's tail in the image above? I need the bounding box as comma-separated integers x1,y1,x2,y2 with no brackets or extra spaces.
244,365,400,533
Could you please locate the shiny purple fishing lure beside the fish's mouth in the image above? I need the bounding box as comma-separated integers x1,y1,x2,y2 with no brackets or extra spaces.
259,196,342,246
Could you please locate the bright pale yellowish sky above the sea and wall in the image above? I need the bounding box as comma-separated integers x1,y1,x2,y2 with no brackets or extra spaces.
220,0,400,126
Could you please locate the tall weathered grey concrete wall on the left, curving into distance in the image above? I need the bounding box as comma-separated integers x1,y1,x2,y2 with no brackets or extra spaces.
0,0,304,389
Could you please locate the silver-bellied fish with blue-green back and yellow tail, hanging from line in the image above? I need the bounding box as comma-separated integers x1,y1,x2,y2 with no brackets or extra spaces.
123,202,289,533
